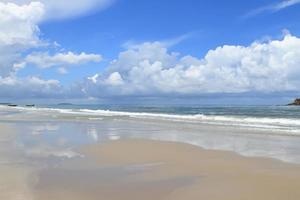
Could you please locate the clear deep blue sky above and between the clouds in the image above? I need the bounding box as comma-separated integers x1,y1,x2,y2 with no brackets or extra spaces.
40,0,300,82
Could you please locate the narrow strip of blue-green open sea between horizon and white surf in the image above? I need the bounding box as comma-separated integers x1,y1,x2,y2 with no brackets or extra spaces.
41,104,300,119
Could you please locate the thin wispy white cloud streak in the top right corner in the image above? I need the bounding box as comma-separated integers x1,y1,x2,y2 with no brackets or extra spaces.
243,0,300,18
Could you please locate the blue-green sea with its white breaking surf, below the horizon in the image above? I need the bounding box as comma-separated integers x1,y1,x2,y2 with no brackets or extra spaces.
40,105,300,135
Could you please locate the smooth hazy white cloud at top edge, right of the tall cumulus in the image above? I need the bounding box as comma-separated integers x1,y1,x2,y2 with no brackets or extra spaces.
0,0,114,19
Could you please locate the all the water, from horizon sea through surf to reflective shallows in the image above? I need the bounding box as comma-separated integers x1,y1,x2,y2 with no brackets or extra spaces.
0,105,300,164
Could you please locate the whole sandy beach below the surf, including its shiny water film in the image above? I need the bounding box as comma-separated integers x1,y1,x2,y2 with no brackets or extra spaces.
0,110,300,200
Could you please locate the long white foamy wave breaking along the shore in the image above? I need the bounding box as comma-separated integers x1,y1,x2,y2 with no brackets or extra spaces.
3,104,300,135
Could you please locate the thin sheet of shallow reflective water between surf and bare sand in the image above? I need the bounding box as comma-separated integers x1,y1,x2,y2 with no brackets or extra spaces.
0,105,300,163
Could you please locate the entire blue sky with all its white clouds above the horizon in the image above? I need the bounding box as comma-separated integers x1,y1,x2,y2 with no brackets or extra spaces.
0,0,300,104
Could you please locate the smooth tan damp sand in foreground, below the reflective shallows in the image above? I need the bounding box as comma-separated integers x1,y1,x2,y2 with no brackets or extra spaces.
35,140,300,200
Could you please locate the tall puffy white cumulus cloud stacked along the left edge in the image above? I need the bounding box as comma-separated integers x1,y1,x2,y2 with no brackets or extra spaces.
0,2,62,98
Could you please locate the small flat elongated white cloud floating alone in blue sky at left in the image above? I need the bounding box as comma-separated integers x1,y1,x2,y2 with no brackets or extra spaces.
25,52,102,68
